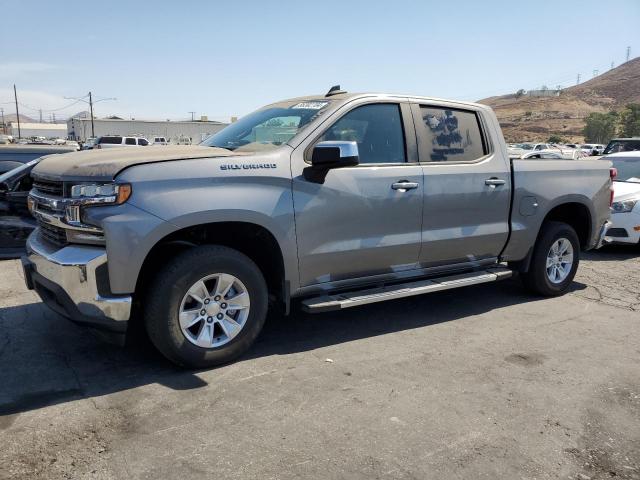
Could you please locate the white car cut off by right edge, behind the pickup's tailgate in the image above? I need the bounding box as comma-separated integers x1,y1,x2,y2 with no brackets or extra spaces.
602,152,640,244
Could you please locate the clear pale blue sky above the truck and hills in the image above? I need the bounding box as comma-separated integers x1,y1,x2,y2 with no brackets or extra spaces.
0,0,640,120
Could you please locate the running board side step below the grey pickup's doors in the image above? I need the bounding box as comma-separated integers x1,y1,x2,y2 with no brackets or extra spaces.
302,266,513,313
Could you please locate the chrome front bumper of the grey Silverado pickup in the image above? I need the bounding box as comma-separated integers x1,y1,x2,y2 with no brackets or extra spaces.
22,229,132,333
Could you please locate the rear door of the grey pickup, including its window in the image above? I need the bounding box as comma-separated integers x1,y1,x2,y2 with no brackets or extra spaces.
412,103,511,269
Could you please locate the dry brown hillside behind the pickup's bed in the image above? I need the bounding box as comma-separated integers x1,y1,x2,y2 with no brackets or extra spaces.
479,57,640,142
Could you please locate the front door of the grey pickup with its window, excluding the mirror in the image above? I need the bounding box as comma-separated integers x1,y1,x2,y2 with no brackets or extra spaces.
292,103,423,286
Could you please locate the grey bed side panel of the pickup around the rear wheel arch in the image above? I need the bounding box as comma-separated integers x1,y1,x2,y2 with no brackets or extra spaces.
502,159,611,261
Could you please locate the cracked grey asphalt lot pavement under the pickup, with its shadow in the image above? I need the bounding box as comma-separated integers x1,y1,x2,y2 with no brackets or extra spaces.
0,248,640,479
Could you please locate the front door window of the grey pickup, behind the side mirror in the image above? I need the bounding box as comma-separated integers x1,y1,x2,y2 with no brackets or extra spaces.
318,103,407,163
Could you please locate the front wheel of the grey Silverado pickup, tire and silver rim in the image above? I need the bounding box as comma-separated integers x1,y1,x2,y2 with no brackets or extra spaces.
143,245,268,368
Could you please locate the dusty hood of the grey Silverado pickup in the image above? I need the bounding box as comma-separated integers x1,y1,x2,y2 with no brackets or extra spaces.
33,145,251,182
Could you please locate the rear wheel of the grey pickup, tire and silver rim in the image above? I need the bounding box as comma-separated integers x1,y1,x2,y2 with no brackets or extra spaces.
521,222,580,297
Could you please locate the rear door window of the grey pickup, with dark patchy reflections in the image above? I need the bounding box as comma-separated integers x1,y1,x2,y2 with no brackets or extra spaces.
419,106,487,162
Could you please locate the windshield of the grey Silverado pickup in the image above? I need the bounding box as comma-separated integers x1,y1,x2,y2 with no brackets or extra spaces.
200,99,330,152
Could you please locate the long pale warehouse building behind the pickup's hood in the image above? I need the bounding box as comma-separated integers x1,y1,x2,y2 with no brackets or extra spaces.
66,117,228,144
